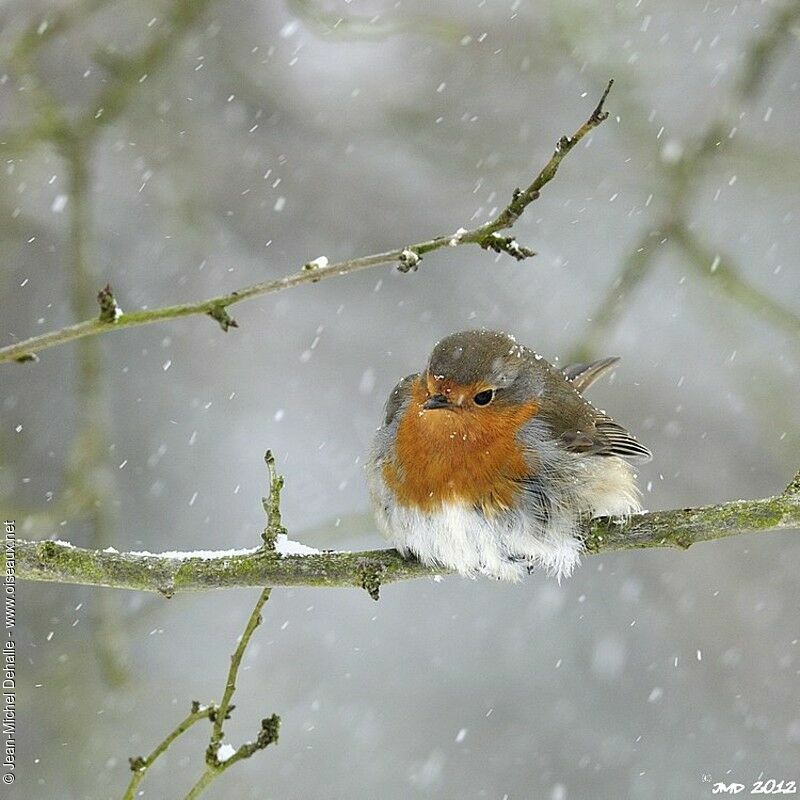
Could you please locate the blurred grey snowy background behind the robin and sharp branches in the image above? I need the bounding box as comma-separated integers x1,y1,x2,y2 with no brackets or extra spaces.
0,0,800,800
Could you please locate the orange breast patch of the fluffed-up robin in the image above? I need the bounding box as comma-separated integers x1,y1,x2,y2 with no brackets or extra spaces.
383,380,538,514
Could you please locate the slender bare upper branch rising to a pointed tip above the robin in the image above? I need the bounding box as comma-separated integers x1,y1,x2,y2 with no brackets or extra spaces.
0,81,613,362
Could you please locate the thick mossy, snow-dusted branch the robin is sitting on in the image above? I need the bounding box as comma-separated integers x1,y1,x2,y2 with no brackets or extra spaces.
7,473,800,597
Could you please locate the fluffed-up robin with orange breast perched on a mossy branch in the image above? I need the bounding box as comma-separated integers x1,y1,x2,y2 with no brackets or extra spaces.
365,330,652,583
